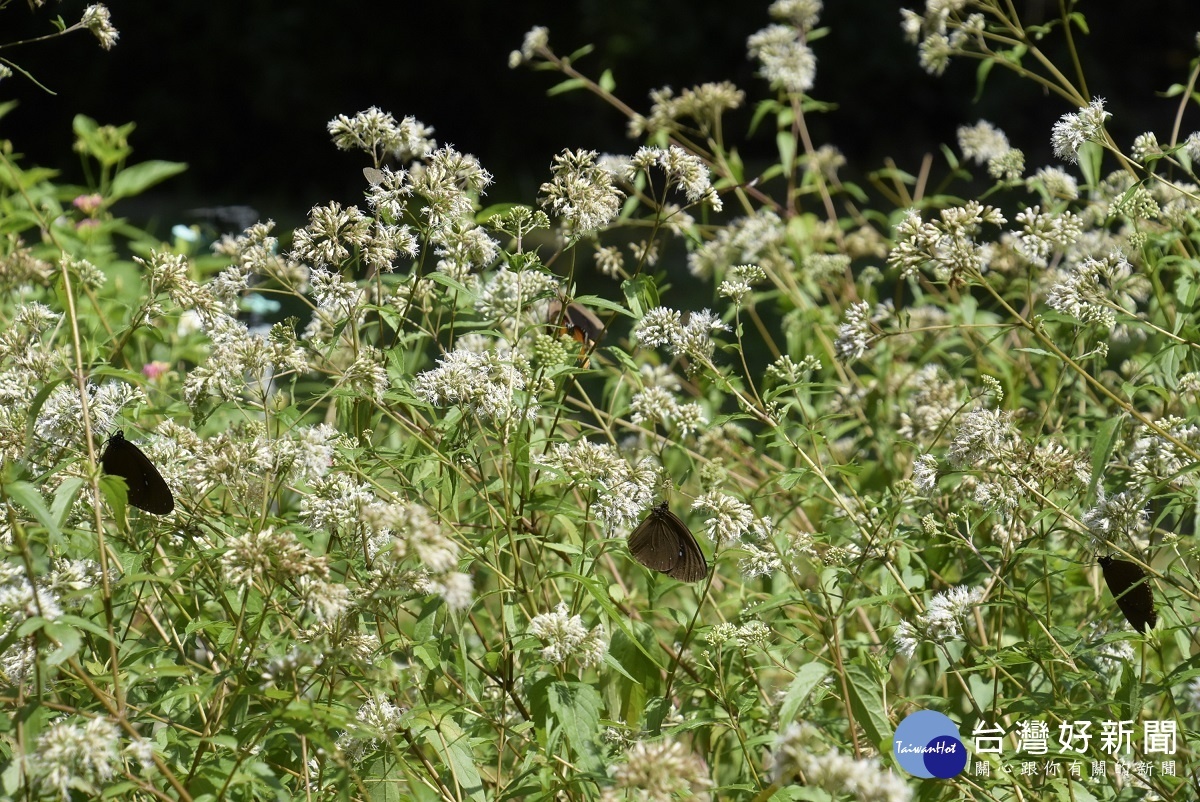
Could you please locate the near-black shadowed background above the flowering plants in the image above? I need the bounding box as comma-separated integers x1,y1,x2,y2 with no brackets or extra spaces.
7,0,1200,234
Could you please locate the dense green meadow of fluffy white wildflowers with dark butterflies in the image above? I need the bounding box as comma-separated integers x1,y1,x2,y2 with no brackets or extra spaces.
0,0,1200,802
